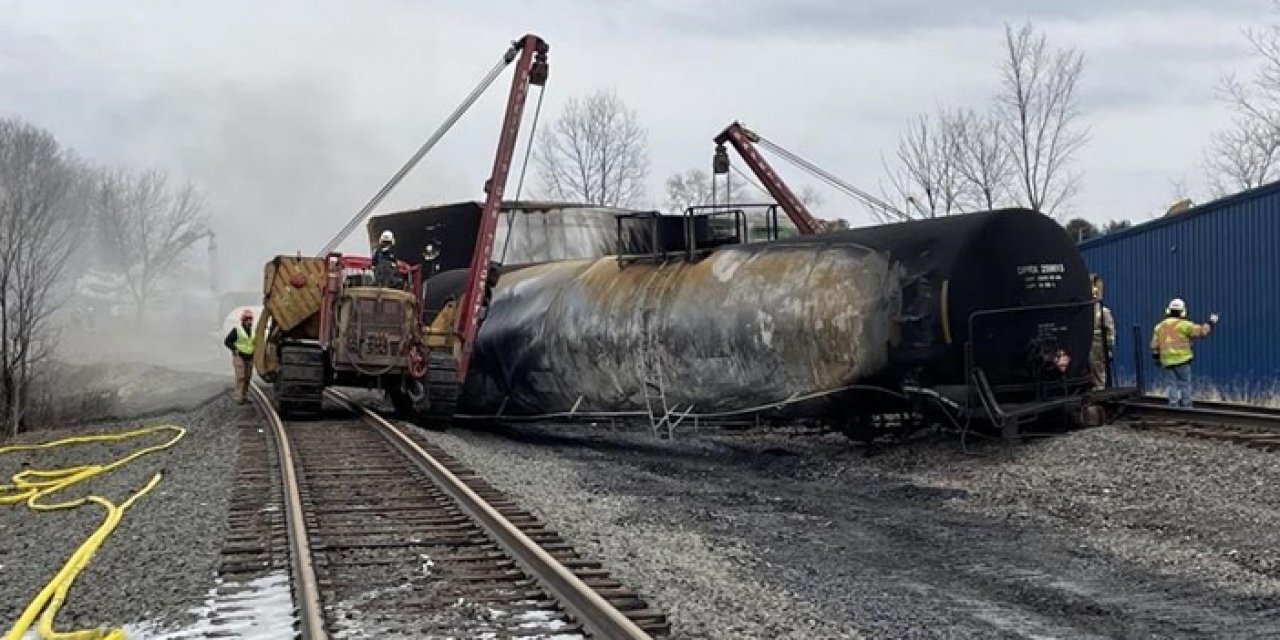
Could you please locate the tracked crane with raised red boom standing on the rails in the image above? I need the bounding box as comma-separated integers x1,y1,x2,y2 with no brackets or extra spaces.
255,35,549,425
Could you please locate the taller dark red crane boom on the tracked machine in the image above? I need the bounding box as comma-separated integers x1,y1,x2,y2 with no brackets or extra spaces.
456,33,550,381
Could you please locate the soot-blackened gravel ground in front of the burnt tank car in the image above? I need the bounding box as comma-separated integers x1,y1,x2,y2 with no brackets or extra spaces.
407,425,1280,637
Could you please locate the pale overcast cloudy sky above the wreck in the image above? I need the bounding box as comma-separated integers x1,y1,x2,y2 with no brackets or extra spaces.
0,0,1271,287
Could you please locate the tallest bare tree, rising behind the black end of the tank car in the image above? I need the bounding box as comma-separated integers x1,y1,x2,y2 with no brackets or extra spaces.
998,24,1088,215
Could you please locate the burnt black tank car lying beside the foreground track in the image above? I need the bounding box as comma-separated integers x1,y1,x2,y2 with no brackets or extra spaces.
414,209,1092,440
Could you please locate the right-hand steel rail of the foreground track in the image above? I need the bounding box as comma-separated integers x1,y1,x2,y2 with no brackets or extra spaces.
328,389,652,640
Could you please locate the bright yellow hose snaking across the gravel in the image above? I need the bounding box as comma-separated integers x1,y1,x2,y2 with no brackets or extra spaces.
0,425,187,640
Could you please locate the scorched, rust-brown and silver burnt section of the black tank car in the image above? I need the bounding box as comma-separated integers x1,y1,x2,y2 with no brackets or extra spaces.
462,243,901,415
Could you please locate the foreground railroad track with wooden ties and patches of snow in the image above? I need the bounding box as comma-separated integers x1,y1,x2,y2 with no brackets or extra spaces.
225,387,669,639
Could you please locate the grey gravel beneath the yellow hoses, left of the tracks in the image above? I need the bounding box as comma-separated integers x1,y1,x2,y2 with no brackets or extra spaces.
0,379,240,631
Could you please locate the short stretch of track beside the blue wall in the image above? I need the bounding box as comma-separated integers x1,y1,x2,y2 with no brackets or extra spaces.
1120,397,1280,451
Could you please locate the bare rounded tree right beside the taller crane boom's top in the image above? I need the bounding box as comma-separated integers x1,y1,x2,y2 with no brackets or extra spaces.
534,91,649,206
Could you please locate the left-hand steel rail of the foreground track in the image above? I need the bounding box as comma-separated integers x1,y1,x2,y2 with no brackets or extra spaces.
250,384,329,640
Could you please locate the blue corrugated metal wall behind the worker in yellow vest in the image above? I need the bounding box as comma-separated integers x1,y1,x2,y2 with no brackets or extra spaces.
1080,184,1280,394
